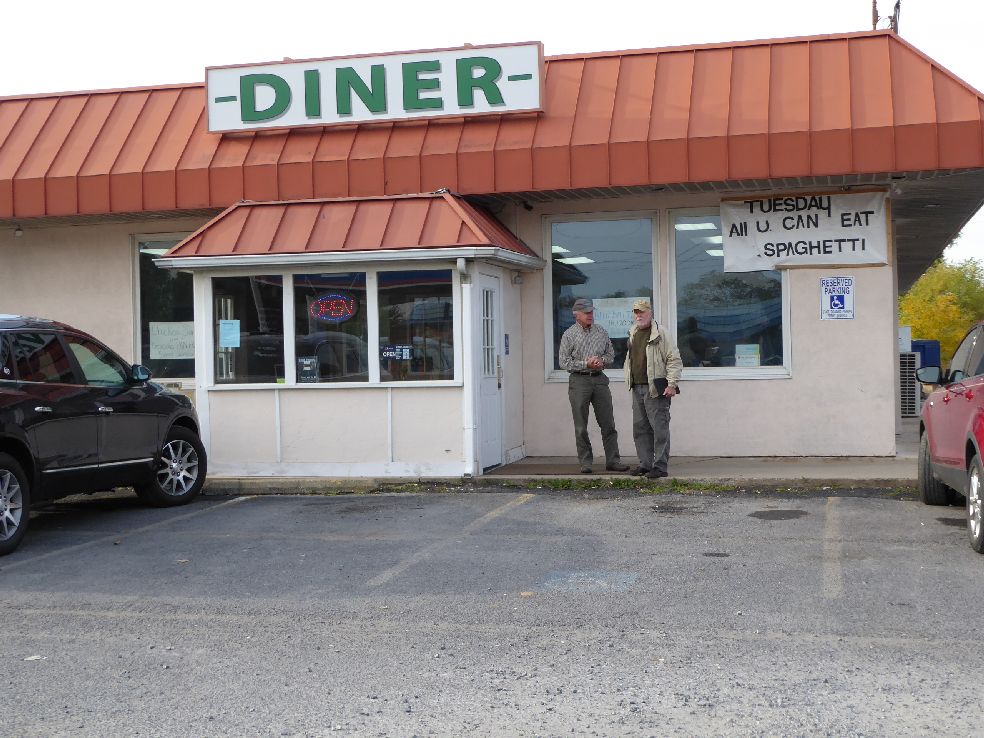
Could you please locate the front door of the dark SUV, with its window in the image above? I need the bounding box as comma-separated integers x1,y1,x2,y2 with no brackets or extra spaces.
64,333,160,485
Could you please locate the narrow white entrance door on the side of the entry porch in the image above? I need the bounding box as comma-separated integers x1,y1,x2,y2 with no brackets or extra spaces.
478,274,502,472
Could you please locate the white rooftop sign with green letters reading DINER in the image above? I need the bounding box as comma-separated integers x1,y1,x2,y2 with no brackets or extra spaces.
205,42,544,132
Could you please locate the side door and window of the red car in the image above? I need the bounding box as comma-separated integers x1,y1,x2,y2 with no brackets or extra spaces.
929,327,984,468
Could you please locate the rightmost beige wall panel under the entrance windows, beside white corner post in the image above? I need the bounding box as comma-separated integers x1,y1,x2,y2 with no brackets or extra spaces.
390,387,464,464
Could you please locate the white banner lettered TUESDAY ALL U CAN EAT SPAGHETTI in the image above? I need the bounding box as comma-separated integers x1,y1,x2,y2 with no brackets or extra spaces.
721,192,888,272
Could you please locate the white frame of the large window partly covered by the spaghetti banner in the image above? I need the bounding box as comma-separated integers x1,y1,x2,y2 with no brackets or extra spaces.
654,207,792,381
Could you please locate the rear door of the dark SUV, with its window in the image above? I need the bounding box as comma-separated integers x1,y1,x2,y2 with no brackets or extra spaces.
12,331,99,497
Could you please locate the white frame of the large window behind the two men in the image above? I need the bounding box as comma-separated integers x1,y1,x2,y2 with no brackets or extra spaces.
541,209,665,382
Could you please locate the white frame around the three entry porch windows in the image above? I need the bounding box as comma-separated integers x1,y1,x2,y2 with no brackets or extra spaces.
202,260,464,392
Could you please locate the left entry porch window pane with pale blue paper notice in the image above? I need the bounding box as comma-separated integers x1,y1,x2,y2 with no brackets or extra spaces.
212,275,285,384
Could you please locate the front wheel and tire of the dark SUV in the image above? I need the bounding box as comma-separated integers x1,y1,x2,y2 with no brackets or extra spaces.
134,426,207,507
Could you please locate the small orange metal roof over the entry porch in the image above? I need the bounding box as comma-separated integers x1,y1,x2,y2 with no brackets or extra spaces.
166,192,537,259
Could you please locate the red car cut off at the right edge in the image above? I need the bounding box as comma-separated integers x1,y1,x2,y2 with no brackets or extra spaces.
916,322,984,553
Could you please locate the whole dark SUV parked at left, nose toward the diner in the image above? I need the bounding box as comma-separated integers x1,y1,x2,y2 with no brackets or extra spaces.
0,315,206,555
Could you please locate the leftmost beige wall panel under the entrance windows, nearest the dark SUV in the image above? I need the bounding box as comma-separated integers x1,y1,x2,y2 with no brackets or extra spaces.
208,390,277,466
